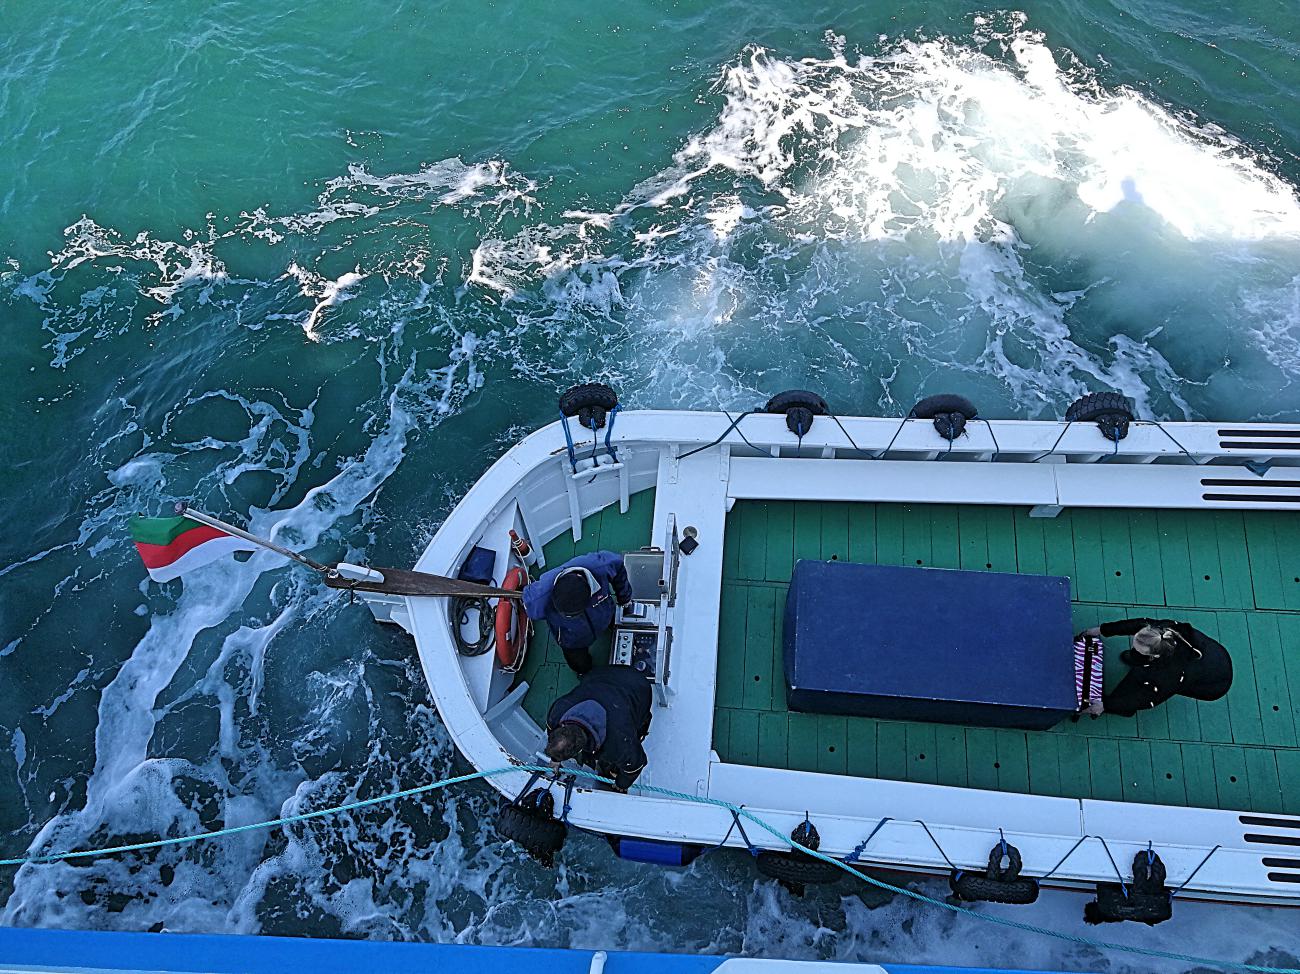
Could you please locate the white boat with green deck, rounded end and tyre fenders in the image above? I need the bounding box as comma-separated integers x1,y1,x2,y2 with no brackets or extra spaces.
351,384,1300,905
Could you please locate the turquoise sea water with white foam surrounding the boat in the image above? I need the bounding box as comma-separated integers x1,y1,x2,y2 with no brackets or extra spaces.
0,0,1300,971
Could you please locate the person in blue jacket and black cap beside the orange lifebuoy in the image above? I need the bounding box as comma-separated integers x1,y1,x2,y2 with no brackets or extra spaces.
524,551,632,676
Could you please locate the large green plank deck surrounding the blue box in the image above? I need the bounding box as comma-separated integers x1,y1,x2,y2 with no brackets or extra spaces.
717,501,1300,814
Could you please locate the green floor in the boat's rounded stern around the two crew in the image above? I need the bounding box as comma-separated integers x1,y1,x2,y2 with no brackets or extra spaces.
519,488,654,724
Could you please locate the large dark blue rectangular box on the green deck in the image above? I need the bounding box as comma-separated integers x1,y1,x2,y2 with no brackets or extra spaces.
784,560,1078,730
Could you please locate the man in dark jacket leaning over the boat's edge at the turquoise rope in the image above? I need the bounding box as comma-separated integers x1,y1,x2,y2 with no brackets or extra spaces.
545,666,650,792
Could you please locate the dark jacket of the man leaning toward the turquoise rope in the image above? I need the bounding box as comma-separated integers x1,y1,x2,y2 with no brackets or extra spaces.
546,666,650,791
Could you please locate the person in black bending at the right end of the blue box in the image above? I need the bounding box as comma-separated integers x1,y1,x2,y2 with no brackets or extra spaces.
1088,619,1232,717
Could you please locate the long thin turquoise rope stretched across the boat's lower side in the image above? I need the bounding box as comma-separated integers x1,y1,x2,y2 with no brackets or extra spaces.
0,765,1300,974
